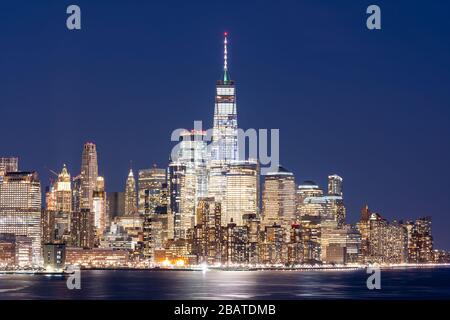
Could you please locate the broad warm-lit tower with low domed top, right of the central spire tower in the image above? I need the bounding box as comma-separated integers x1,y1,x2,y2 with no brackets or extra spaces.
262,167,296,226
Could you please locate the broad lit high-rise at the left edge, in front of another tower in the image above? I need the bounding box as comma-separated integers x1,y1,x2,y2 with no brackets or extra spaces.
0,171,41,264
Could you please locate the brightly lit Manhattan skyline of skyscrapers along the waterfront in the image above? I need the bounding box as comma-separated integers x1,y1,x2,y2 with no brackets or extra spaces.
0,26,442,264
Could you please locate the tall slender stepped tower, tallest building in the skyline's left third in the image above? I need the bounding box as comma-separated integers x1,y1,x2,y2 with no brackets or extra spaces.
80,142,98,212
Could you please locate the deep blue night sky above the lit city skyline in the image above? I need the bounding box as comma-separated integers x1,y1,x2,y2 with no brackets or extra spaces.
0,0,450,249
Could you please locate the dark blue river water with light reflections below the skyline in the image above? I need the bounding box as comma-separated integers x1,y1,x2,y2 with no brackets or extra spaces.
0,268,450,300
